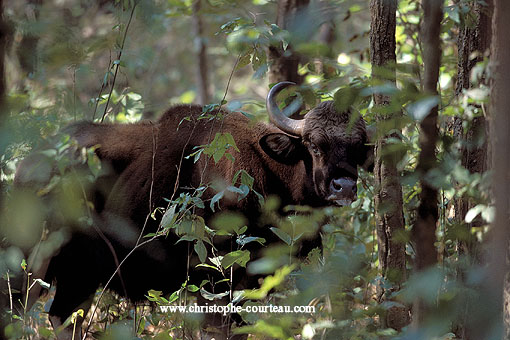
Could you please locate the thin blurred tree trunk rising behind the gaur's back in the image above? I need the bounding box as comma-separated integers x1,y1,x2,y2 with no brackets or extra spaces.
192,0,211,105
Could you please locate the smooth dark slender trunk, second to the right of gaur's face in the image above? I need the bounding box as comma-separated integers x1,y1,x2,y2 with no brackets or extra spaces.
411,0,443,327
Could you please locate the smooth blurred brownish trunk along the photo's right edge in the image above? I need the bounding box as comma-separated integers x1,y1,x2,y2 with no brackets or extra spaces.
492,0,510,339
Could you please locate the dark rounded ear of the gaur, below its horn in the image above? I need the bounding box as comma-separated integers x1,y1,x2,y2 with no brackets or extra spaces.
259,133,304,165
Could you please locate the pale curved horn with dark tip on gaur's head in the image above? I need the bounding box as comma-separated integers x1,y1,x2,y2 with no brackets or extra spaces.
266,81,305,136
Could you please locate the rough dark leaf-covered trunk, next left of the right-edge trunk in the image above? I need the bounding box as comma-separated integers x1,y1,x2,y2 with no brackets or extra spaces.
453,0,493,340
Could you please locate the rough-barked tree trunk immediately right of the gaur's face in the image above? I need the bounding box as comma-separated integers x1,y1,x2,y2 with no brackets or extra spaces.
370,0,409,329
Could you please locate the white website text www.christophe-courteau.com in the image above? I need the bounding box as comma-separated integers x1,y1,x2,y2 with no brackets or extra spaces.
159,304,315,315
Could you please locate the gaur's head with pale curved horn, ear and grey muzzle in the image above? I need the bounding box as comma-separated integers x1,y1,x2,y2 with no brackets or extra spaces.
260,82,372,206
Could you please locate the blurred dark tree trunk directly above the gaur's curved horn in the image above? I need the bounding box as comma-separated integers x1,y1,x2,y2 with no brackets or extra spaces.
269,0,309,85
